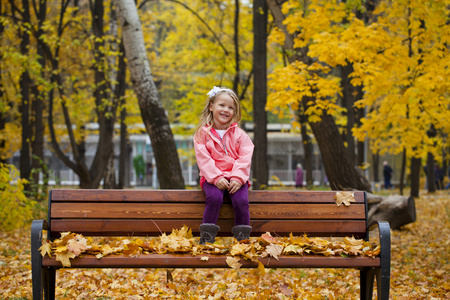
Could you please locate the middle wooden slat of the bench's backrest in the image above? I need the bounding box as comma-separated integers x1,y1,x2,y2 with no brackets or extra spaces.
51,202,365,220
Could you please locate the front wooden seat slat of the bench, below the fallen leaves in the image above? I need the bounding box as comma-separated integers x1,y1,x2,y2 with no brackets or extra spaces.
42,254,380,268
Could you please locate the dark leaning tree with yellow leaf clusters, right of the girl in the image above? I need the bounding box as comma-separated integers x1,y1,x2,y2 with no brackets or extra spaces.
267,0,370,191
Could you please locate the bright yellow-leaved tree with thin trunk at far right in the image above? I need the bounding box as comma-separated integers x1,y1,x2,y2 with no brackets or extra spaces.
311,1,449,196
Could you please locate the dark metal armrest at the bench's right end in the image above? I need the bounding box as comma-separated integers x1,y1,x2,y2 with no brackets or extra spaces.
369,221,391,277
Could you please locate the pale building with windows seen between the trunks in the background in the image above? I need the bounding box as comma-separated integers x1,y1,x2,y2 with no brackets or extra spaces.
13,124,325,188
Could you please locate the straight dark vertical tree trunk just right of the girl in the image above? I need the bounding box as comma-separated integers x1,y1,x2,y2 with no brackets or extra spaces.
252,0,269,190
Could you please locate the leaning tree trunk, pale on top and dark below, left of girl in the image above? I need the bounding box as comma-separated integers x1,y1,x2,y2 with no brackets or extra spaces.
114,0,184,189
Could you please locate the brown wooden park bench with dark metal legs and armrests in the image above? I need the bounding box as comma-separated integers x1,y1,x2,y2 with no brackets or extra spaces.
31,189,391,300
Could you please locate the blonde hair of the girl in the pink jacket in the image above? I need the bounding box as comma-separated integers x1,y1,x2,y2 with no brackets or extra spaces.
194,88,241,136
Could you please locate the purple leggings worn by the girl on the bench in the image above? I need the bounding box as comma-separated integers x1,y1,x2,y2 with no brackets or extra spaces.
203,182,250,225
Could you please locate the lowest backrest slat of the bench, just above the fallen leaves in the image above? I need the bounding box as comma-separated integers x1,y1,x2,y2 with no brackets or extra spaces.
50,219,367,238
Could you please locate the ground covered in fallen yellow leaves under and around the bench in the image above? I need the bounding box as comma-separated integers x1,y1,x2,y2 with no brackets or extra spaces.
0,191,450,300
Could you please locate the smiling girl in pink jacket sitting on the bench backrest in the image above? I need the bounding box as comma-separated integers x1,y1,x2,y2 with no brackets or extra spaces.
194,86,254,245
